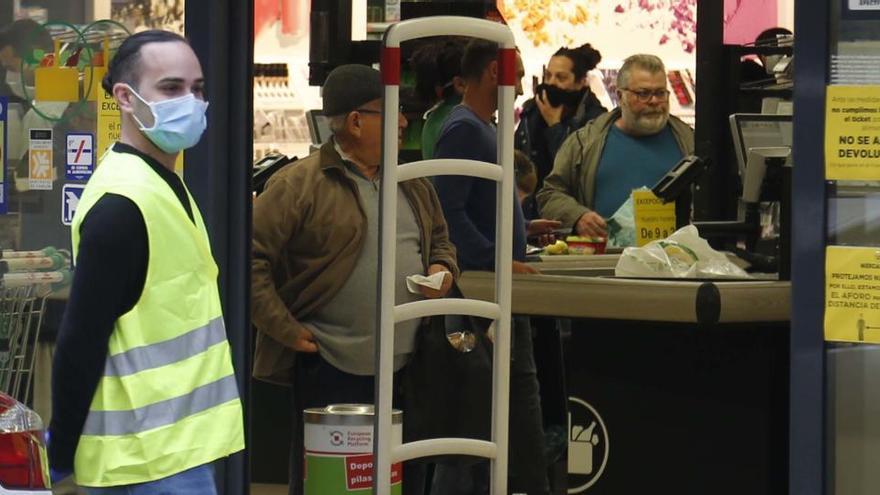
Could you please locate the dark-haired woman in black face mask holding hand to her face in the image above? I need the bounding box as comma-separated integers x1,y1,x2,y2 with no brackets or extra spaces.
515,43,607,210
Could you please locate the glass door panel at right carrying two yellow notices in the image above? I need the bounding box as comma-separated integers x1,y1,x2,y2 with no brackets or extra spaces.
824,0,880,495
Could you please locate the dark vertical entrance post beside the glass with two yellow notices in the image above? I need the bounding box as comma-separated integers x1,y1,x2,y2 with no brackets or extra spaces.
789,0,832,495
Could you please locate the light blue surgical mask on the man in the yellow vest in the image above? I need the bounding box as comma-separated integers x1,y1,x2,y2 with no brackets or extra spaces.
128,86,208,153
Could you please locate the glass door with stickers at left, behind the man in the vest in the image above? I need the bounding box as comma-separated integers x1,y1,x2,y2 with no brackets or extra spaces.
0,0,184,424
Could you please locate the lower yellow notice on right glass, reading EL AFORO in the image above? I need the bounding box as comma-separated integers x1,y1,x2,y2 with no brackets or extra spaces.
825,246,880,344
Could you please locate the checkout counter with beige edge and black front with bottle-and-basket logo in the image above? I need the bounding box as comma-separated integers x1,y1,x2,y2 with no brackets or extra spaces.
459,255,790,495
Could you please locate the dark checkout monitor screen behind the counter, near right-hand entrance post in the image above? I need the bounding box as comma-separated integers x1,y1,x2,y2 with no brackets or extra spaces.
730,113,792,177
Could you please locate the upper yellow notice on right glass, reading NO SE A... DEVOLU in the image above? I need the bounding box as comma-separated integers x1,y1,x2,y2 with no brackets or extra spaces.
825,86,880,180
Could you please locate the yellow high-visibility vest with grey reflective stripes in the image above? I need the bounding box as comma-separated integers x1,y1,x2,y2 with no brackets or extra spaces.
71,149,244,487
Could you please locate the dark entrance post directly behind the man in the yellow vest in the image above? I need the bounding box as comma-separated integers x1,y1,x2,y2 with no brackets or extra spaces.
184,0,254,495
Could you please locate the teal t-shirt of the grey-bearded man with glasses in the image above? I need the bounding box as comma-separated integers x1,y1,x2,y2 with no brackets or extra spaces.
594,125,682,218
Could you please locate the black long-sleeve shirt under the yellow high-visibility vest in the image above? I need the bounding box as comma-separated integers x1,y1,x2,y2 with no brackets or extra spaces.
49,143,193,470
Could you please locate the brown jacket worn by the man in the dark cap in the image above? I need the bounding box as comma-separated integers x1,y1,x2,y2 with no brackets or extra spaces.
251,142,458,385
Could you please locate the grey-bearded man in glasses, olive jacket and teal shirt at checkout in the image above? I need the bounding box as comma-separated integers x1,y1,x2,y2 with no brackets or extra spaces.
537,54,694,237
